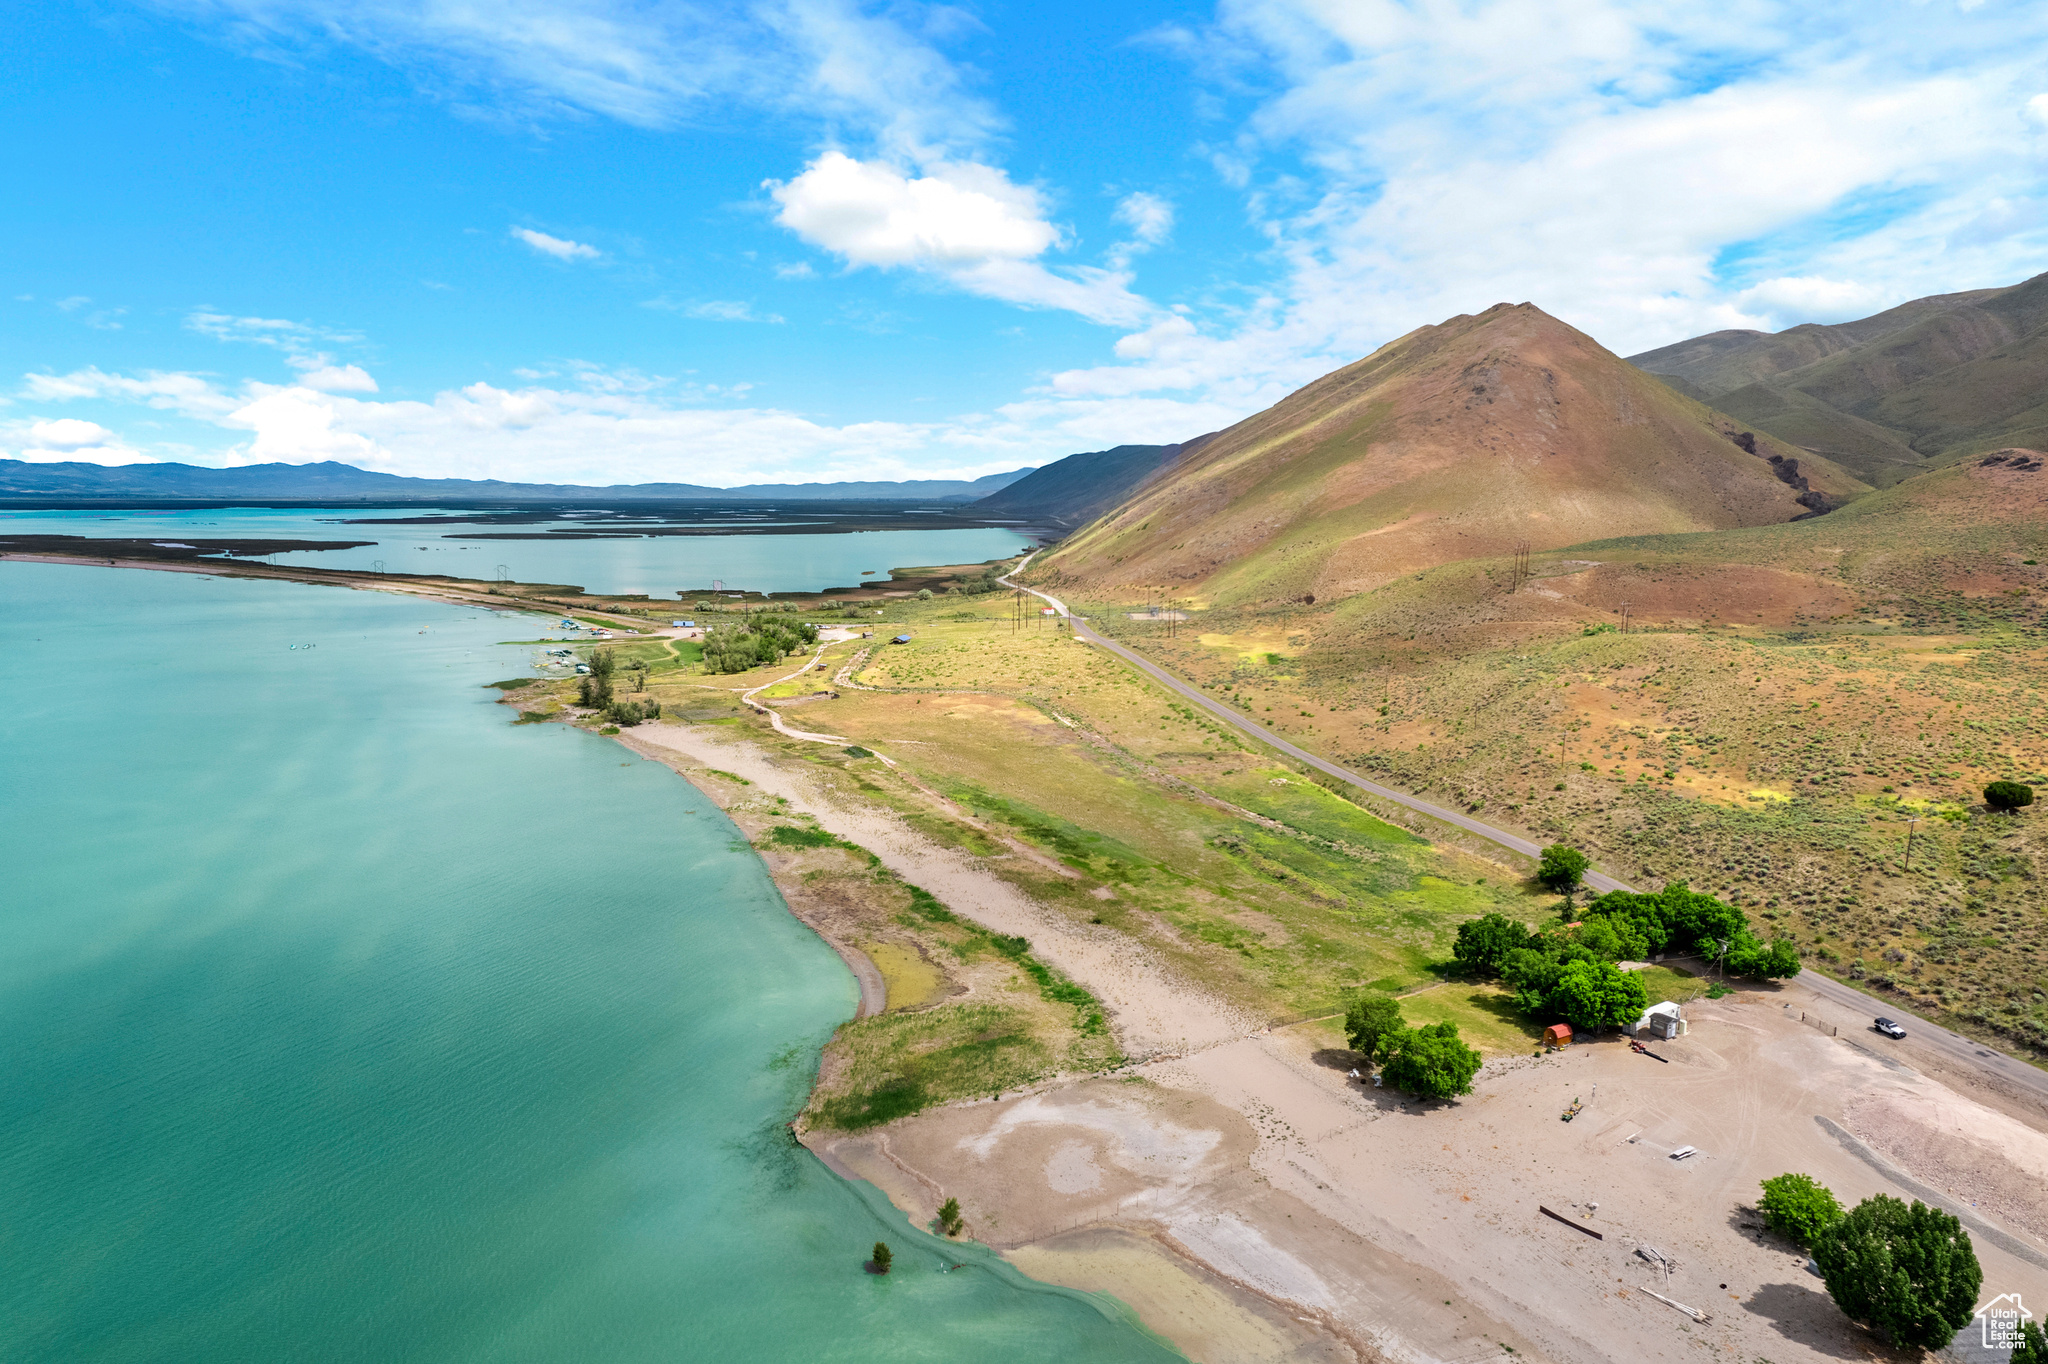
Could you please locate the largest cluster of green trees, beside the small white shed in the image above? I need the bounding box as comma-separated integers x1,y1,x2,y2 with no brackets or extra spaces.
1452,881,1800,1030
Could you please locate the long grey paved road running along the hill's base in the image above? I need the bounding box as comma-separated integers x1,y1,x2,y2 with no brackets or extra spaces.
1004,557,2048,1100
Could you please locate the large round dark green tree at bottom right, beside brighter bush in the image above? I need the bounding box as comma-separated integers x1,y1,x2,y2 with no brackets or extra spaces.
1812,1194,1985,1350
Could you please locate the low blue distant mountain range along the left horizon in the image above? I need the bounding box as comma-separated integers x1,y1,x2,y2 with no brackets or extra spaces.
0,459,1032,504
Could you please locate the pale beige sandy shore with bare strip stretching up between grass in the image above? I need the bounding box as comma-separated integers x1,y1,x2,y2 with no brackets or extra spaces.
621,712,2048,1364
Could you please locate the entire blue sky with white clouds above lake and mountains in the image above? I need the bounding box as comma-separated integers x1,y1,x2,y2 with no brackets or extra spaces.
0,0,2048,483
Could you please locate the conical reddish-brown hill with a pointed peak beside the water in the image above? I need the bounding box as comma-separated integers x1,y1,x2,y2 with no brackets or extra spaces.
1044,303,1868,606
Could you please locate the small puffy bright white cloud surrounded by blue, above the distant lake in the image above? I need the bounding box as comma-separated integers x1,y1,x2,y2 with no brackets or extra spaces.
768,152,1155,324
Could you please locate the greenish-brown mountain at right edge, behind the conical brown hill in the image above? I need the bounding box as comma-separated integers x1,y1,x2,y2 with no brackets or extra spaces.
1628,274,2048,487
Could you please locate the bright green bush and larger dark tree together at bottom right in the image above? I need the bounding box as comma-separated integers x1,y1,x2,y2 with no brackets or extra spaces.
1757,1174,2015,1364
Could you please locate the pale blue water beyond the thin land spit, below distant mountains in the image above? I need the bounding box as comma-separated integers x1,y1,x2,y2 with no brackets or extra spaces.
0,506,1030,598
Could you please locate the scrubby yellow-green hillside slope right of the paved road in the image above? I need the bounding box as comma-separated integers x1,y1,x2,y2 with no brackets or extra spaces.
1090,453,2048,1057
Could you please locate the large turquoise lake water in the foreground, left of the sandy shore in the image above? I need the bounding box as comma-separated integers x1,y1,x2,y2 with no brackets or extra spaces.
0,563,1180,1364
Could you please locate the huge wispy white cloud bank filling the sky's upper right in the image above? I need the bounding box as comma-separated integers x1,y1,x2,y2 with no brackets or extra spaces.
1044,0,2048,412
